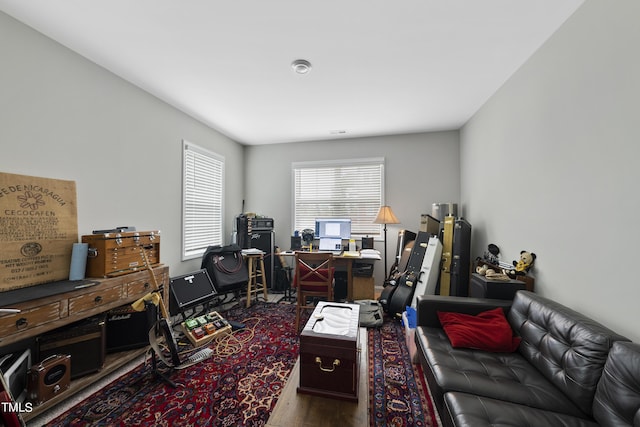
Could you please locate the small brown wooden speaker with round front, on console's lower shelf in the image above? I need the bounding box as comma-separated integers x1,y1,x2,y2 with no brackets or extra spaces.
27,354,71,405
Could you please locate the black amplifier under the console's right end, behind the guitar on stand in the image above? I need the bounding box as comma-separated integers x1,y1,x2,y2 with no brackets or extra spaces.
106,305,155,353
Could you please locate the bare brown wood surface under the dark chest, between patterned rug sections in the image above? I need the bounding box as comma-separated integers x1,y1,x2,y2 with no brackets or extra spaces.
265,328,369,427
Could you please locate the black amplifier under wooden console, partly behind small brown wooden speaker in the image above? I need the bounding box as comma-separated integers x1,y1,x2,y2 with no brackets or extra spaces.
35,315,106,379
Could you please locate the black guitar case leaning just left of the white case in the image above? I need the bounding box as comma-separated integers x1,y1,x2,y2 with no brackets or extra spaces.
388,231,431,317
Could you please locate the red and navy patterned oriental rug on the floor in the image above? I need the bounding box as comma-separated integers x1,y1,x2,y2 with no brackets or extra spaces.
47,302,438,427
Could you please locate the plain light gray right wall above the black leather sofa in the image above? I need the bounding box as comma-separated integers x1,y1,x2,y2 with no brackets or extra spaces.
461,0,640,341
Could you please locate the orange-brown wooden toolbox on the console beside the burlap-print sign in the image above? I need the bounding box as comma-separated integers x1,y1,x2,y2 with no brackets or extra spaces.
82,231,160,277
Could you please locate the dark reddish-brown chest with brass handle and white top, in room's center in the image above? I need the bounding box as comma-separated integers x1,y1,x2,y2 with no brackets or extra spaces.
297,301,360,402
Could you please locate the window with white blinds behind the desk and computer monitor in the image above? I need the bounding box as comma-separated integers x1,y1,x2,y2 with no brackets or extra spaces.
292,158,384,237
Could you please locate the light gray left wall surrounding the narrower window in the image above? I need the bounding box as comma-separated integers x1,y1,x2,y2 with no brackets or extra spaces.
0,12,244,274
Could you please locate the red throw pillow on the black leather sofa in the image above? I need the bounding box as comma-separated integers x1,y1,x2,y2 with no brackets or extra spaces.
438,308,520,353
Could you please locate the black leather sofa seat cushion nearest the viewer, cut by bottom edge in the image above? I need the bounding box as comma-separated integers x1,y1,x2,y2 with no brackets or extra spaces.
443,392,598,427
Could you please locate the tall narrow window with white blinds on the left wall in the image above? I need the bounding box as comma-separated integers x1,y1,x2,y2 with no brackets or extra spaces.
181,140,225,261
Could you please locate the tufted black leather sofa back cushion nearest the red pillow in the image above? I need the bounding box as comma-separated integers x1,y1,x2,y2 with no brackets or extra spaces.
507,291,628,415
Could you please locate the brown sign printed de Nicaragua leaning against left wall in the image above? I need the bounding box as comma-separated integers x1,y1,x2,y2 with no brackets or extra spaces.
0,172,78,292
